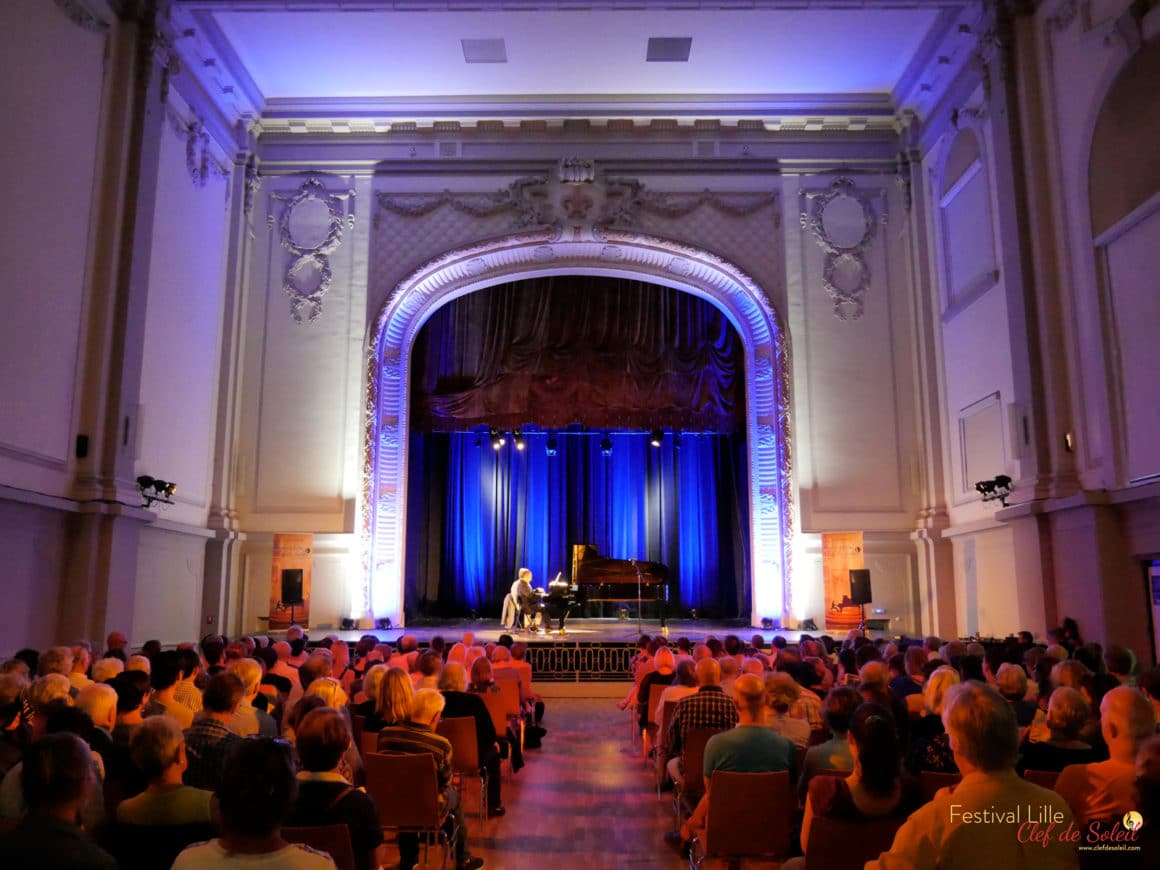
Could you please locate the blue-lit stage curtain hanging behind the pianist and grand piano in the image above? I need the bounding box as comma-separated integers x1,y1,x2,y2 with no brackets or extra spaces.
405,432,749,619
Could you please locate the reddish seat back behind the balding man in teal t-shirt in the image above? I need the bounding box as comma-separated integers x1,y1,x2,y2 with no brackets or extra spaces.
704,770,797,860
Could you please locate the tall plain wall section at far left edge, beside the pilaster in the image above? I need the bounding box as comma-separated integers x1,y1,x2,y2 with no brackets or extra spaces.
0,0,106,494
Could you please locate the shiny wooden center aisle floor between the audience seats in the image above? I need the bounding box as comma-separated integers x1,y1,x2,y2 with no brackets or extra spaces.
467,698,688,870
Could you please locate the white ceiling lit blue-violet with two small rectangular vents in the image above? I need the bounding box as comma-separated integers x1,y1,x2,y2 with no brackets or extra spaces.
173,0,977,127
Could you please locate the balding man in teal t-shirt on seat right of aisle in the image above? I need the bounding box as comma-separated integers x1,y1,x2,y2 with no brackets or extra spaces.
667,674,795,849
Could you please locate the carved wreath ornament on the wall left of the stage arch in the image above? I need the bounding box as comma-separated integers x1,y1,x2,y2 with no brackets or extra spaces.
268,175,355,324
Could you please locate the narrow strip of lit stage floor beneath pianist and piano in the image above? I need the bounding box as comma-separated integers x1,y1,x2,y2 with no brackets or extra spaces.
277,619,824,646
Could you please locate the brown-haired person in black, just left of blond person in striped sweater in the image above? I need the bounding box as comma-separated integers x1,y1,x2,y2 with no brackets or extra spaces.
285,706,383,870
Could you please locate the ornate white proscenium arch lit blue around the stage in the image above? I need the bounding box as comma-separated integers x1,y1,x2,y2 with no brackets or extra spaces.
366,234,793,625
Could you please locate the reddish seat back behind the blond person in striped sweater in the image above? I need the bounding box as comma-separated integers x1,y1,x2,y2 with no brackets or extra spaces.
363,752,443,831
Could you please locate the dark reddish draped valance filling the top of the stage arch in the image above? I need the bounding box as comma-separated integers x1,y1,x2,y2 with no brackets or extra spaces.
411,275,745,433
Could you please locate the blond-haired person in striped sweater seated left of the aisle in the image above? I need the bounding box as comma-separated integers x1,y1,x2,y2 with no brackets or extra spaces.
378,689,484,870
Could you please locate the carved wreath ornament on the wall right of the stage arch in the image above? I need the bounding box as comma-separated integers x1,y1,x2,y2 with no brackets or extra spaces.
799,176,886,320
